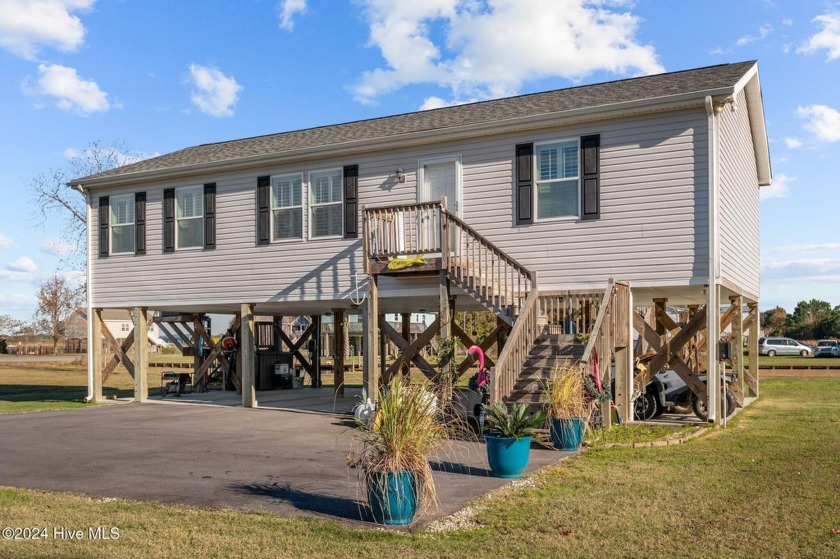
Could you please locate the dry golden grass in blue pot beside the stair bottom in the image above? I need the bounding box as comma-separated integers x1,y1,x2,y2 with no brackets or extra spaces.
545,365,589,450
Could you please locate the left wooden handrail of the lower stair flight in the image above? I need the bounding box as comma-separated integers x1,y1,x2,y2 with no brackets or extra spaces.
490,277,540,403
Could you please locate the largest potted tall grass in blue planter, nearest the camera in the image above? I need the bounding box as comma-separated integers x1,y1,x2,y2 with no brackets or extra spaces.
354,381,448,525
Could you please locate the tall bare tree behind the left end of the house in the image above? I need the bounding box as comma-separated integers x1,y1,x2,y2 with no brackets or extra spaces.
29,141,141,267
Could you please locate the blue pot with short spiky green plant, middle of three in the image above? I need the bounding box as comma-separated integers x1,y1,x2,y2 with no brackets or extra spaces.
483,402,545,478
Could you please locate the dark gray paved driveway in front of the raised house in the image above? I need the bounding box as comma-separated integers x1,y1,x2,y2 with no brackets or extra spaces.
0,403,567,525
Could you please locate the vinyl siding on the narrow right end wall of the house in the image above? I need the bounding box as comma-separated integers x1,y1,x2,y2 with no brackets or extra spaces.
718,92,761,297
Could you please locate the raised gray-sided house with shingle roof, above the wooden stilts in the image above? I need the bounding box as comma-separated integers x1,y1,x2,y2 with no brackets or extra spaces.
70,61,771,420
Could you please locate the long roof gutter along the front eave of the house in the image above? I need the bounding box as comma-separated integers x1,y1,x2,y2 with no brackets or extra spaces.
67,87,733,188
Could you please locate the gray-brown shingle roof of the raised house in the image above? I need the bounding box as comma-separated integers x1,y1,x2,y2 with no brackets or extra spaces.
71,61,755,184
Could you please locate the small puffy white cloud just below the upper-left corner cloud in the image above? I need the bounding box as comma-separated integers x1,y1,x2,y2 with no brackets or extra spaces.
23,64,111,116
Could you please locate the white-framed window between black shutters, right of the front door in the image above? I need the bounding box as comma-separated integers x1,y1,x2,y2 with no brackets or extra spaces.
536,139,580,219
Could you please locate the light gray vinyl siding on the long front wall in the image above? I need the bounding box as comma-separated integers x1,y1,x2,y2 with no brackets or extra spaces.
90,110,708,307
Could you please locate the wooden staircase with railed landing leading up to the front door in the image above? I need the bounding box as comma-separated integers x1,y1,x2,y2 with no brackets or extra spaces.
363,199,629,412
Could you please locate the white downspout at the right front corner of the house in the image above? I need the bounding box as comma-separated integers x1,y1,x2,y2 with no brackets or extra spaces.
705,95,721,424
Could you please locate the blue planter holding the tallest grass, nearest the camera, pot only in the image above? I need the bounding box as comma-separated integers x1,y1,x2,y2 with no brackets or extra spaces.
367,471,418,526
